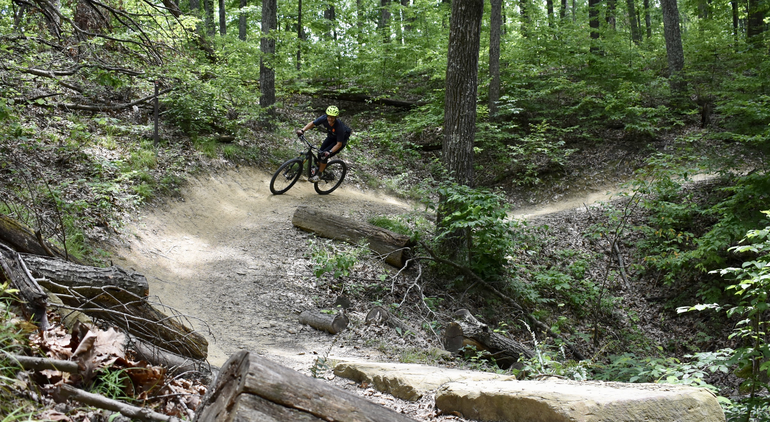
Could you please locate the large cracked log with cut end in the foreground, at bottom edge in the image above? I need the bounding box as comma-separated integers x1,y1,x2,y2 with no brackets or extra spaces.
193,351,414,422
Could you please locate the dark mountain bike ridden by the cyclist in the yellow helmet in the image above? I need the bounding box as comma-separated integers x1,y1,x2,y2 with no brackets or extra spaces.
270,135,348,195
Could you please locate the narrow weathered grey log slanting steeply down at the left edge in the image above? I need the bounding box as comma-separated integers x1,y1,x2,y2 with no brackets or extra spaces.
0,243,48,330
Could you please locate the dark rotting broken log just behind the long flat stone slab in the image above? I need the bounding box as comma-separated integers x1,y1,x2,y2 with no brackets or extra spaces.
444,309,535,367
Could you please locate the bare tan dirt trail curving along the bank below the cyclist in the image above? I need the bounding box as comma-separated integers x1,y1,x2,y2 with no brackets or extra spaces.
112,167,411,372
